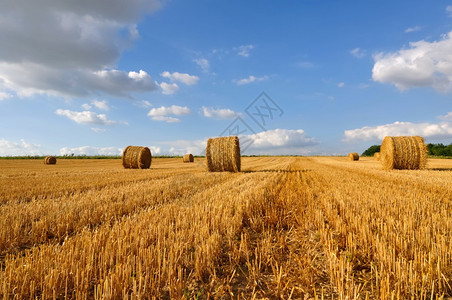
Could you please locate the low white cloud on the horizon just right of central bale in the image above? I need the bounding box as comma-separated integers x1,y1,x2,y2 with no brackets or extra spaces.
246,129,319,154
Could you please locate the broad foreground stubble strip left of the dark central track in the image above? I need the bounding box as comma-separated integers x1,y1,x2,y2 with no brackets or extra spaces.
0,173,283,298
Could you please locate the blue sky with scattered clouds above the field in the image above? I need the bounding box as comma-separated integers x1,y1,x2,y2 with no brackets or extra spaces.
0,0,452,156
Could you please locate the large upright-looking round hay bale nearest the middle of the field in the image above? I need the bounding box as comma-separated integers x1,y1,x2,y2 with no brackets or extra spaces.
206,136,240,172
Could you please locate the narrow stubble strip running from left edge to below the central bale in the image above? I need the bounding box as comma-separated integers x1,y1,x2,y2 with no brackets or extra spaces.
0,173,233,255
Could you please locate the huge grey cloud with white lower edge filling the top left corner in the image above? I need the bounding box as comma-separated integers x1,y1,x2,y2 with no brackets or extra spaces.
0,0,161,97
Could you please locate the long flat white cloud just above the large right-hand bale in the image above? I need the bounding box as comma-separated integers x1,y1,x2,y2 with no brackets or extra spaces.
344,119,452,142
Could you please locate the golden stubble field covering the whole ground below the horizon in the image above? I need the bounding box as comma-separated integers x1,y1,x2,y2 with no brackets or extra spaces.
0,157,452,299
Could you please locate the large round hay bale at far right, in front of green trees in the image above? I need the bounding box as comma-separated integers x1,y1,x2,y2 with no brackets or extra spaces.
380,136,427,170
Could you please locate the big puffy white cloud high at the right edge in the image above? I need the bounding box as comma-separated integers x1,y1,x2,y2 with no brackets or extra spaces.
372,32,452,92
